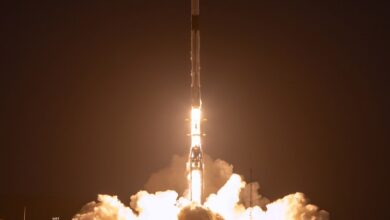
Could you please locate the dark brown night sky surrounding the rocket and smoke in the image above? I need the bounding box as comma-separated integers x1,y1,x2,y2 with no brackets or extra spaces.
0,0,390,220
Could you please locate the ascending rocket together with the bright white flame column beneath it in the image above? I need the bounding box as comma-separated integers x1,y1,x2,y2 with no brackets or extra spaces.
187,0,204,205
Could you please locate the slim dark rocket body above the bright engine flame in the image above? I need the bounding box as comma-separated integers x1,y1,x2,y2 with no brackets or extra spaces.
191,0,202,107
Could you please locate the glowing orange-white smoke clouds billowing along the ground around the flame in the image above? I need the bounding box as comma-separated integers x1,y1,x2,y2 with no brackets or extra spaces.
74,155,329,220
